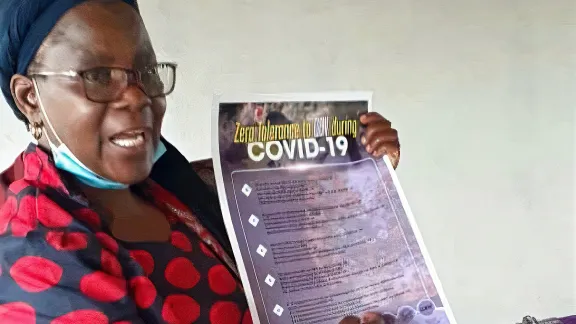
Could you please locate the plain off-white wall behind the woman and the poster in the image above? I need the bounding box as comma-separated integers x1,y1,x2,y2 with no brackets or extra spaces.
0,0,576,324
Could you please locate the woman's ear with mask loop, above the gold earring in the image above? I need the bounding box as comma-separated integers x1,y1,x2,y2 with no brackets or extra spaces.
10,74,41,122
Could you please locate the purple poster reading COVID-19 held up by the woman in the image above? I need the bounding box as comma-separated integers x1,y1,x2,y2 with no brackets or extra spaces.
213,93,456,324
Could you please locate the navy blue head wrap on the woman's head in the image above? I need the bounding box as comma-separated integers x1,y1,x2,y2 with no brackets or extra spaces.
0,0,138,121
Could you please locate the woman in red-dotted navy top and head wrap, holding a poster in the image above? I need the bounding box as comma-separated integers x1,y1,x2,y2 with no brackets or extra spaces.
0,0,398,324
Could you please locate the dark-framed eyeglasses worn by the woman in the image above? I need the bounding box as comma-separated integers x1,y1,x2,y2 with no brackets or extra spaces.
29,63,177,103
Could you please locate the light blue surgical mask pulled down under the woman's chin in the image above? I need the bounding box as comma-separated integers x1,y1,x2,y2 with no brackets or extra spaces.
33,80,166,190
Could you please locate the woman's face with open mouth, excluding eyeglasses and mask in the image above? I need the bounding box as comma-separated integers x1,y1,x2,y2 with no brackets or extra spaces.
13,1,166,184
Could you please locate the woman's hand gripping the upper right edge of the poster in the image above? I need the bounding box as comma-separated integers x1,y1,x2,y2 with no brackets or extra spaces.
360,112,400,169
